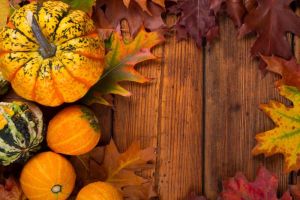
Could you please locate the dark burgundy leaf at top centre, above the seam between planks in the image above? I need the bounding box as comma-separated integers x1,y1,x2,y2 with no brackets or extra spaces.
169,0,219,47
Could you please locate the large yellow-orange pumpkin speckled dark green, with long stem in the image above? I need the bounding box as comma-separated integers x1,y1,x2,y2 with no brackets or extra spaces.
0,1,104,106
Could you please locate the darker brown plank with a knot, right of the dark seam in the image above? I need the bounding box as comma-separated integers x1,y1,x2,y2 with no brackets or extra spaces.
204,19,288,199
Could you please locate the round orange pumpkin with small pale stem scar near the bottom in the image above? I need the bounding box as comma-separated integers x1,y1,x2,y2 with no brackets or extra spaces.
20,152,76,200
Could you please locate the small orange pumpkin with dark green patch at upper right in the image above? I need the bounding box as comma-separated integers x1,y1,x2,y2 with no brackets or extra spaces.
47,105,101,155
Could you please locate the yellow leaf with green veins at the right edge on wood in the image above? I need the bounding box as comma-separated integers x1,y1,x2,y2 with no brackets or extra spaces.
252,85,300,172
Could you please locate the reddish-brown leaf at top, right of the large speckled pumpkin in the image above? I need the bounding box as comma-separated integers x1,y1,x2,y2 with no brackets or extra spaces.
93,0,166,36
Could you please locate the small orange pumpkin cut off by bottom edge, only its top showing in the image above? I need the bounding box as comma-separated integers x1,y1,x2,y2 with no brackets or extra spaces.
76,181,123,200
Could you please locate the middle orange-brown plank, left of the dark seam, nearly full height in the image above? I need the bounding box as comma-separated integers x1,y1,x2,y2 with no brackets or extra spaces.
158,19,203,200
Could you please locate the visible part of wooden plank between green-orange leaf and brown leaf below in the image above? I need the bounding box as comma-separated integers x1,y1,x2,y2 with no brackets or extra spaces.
112,21,163,188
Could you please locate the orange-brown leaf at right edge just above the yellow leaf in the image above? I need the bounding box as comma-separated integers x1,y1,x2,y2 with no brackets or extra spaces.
261,56,300,89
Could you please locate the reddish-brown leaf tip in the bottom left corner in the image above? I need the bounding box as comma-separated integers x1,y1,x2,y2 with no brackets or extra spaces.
0,177,26,200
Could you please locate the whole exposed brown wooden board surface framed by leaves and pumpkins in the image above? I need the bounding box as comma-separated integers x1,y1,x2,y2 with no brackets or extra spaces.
102,16,300,200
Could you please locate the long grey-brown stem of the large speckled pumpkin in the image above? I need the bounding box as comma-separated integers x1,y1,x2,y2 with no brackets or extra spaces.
27,12,56,58
